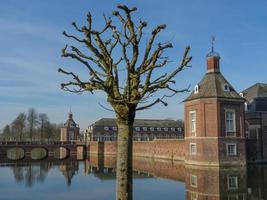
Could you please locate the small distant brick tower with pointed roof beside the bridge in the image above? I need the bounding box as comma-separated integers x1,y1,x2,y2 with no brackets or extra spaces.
60,112,80,142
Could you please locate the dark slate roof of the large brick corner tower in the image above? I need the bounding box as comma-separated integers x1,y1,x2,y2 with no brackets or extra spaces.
185,72,244,101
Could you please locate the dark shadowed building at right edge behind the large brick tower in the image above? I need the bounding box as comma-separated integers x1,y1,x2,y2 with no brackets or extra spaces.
244,83,267,162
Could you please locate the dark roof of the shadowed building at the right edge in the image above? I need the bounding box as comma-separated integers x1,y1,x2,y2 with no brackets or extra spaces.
242,83,267,101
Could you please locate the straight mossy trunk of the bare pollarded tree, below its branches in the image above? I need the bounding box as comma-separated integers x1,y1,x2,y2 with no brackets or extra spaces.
116,121,133,200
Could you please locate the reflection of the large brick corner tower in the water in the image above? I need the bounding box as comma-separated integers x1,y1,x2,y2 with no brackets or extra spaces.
185,166,247,200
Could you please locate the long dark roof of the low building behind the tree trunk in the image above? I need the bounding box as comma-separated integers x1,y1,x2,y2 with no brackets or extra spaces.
92,118,180,127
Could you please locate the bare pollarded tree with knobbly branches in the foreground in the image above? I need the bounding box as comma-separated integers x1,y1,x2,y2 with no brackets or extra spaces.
58,5,191,200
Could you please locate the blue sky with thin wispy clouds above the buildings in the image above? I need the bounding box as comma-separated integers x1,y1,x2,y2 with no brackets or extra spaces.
0,0,267,129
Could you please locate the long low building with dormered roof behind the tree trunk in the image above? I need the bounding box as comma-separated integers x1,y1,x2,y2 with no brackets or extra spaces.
86,118,184,141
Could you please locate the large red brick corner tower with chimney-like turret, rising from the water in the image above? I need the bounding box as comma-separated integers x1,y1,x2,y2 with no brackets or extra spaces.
184,44,246,166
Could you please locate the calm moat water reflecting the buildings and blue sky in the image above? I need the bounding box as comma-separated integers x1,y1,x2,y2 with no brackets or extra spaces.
0,157,267,200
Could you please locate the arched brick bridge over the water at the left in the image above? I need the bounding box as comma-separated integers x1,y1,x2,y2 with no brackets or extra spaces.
0,141,86,162
